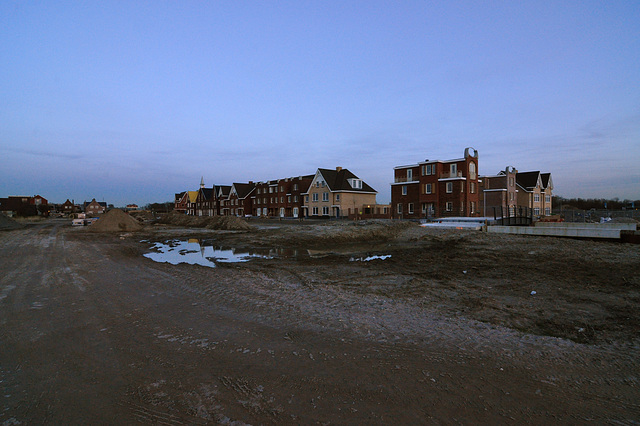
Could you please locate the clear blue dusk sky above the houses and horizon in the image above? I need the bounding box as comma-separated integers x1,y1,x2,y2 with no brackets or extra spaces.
0,0,640,205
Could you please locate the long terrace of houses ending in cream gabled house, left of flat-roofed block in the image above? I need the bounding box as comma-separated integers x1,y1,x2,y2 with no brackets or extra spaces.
174,167,390,218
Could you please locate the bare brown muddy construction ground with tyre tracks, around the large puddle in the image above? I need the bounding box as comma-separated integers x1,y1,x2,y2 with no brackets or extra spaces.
0,219,640,425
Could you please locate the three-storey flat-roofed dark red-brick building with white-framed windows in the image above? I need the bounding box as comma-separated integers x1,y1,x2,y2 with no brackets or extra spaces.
391,148,481,219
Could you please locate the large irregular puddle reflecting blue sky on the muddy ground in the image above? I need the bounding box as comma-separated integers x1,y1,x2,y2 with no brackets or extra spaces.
144,238,299,267
